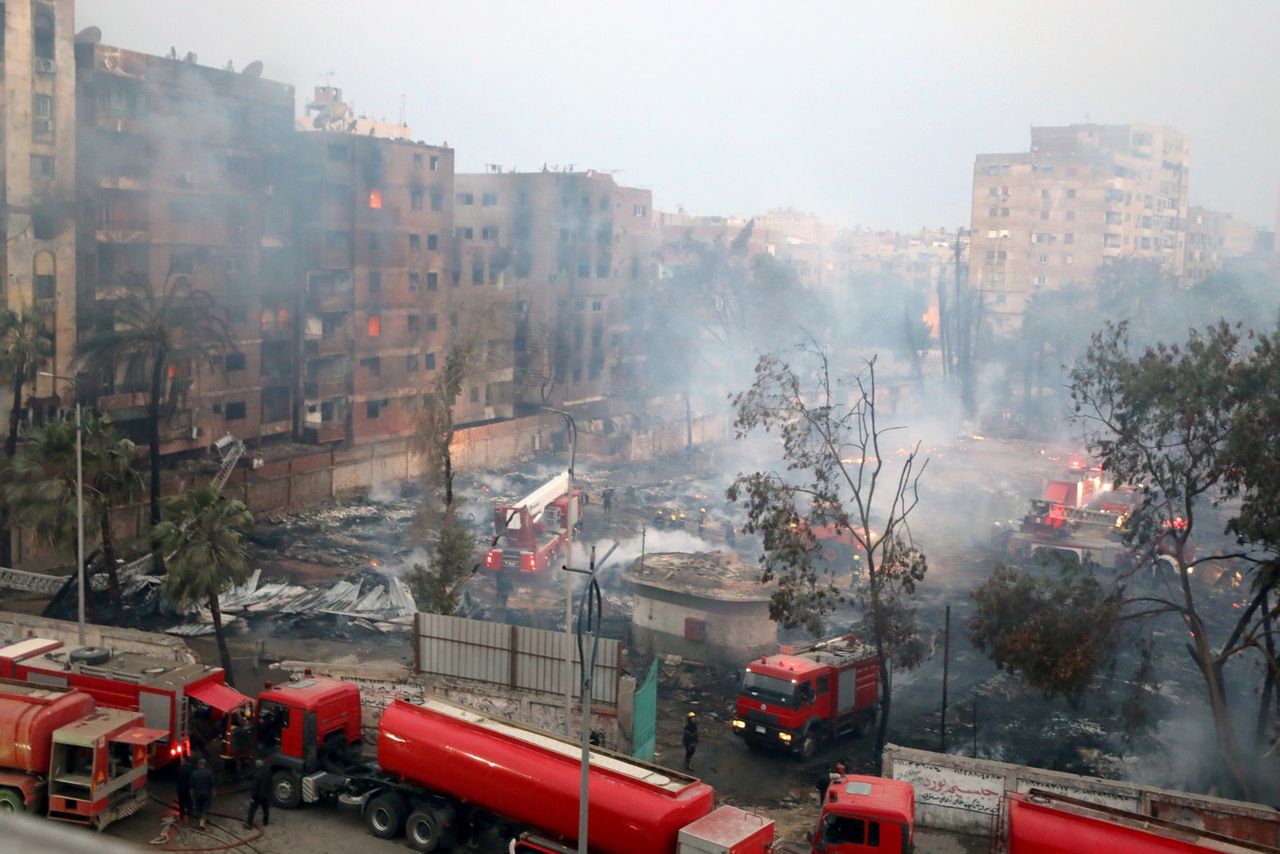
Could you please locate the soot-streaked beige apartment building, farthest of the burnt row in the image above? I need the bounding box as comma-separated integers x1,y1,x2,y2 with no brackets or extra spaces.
453,168,654,411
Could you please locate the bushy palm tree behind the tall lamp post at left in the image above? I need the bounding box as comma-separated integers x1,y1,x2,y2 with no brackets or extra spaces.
0,416,142,624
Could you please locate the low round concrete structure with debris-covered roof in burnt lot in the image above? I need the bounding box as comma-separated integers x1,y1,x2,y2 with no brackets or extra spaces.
623,552,778,667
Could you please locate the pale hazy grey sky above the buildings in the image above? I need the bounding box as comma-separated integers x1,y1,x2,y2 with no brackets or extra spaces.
77,0,1280,229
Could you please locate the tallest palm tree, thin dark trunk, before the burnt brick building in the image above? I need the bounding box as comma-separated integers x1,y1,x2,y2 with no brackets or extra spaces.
79,274,232,535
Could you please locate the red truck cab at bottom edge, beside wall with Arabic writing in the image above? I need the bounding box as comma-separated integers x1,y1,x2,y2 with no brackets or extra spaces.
813,775,915,854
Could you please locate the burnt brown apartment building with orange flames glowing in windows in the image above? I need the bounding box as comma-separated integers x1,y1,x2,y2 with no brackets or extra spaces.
294,131,468,444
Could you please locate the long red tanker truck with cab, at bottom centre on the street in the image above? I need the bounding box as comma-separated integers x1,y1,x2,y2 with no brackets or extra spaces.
245,676,773,854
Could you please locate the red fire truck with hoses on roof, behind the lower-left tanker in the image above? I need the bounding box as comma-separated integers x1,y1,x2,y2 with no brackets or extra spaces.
0,638,253,767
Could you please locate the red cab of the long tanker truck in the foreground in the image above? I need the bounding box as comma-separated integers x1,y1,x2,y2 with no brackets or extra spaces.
253,675,361,809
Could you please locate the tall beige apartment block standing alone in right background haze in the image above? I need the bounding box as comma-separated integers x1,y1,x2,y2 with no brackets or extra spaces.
969,124,1190,325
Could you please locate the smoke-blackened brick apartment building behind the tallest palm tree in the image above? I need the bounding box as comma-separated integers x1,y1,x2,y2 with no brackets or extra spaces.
76,40,297,455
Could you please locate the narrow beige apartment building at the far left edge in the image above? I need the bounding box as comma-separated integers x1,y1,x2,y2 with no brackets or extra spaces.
0,0,76,412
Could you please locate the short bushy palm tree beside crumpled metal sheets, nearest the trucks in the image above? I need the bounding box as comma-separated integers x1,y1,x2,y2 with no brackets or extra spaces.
154,485,253,682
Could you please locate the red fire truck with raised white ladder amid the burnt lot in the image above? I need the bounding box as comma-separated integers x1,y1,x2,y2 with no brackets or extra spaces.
484,471,586,574
